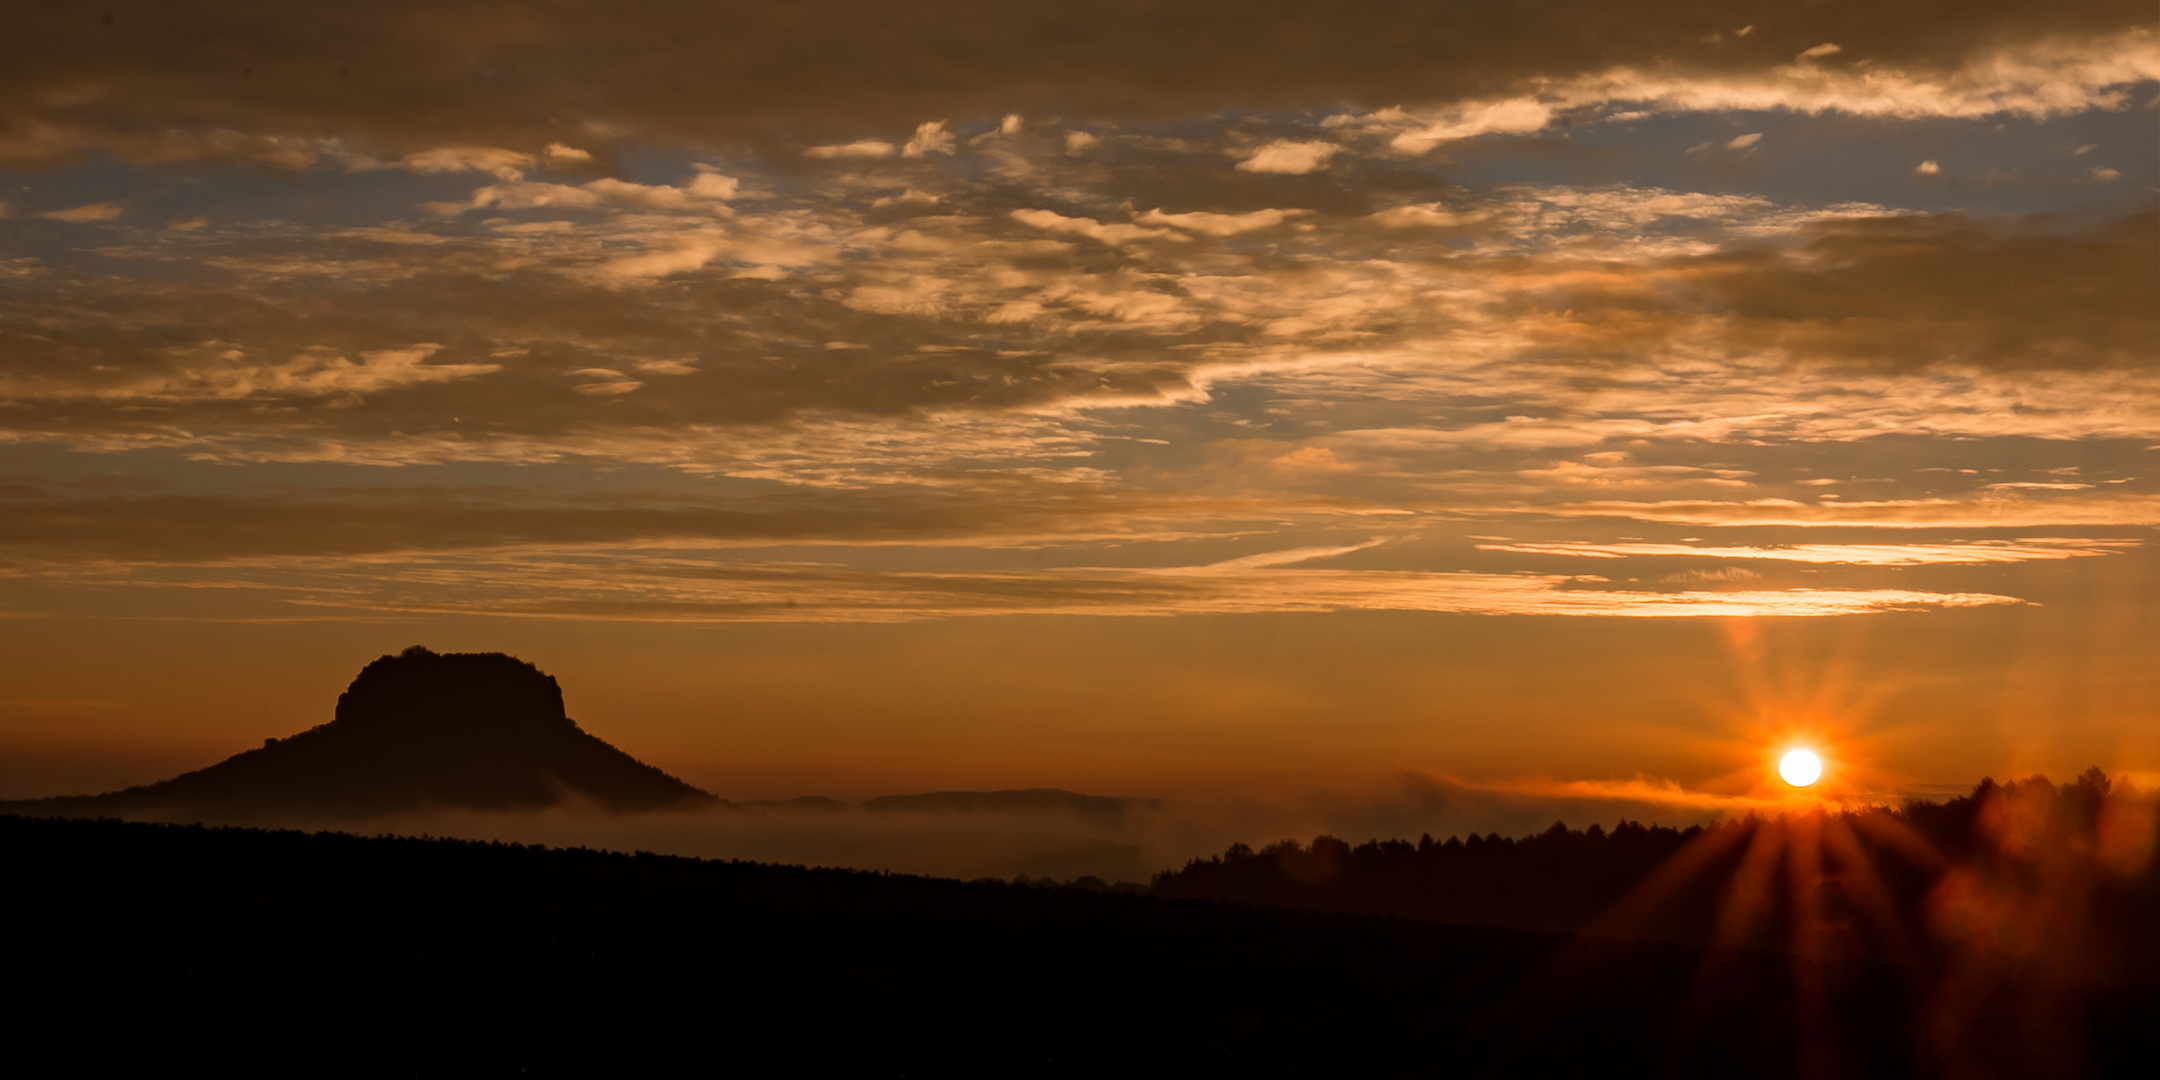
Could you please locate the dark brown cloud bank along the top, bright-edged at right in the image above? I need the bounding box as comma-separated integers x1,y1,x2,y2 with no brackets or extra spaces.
0,0,2154,168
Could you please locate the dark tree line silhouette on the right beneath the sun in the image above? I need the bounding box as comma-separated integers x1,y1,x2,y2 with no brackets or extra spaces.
1151,769,2160,970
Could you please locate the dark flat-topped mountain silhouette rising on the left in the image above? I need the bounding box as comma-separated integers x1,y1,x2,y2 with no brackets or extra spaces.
0,646,724,821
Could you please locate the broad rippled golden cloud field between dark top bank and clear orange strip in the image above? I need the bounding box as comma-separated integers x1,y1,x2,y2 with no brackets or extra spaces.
0,59,2160,639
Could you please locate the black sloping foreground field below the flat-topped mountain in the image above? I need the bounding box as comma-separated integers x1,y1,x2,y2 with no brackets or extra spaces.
0,816,2160,1078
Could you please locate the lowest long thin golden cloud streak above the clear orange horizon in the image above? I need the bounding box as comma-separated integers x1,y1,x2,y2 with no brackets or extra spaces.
0,523,2022,622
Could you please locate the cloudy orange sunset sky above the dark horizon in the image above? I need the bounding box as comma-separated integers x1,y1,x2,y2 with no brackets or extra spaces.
0,0,2160,842
